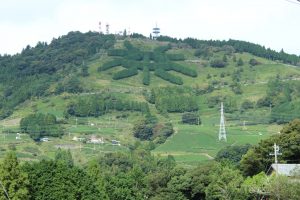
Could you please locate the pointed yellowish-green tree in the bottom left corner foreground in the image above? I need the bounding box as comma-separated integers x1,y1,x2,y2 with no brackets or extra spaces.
0,152,30,200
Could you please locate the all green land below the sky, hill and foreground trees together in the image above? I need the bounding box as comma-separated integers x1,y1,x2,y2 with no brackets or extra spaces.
0,32,300,200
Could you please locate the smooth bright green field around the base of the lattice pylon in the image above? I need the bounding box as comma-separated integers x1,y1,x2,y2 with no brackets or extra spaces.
154,124,281,165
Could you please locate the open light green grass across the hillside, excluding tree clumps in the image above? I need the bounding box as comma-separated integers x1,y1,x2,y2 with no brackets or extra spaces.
0,40,300,165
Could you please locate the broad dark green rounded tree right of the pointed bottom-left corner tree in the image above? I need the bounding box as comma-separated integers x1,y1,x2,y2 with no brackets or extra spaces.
24,160,105,200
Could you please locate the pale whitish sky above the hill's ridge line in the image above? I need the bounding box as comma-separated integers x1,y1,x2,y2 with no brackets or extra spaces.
0,0,300,55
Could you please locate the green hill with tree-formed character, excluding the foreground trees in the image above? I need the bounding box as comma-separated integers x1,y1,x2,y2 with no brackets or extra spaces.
0,32,300,165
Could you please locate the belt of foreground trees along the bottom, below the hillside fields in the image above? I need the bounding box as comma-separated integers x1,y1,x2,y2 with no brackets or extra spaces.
0,120,300,200
